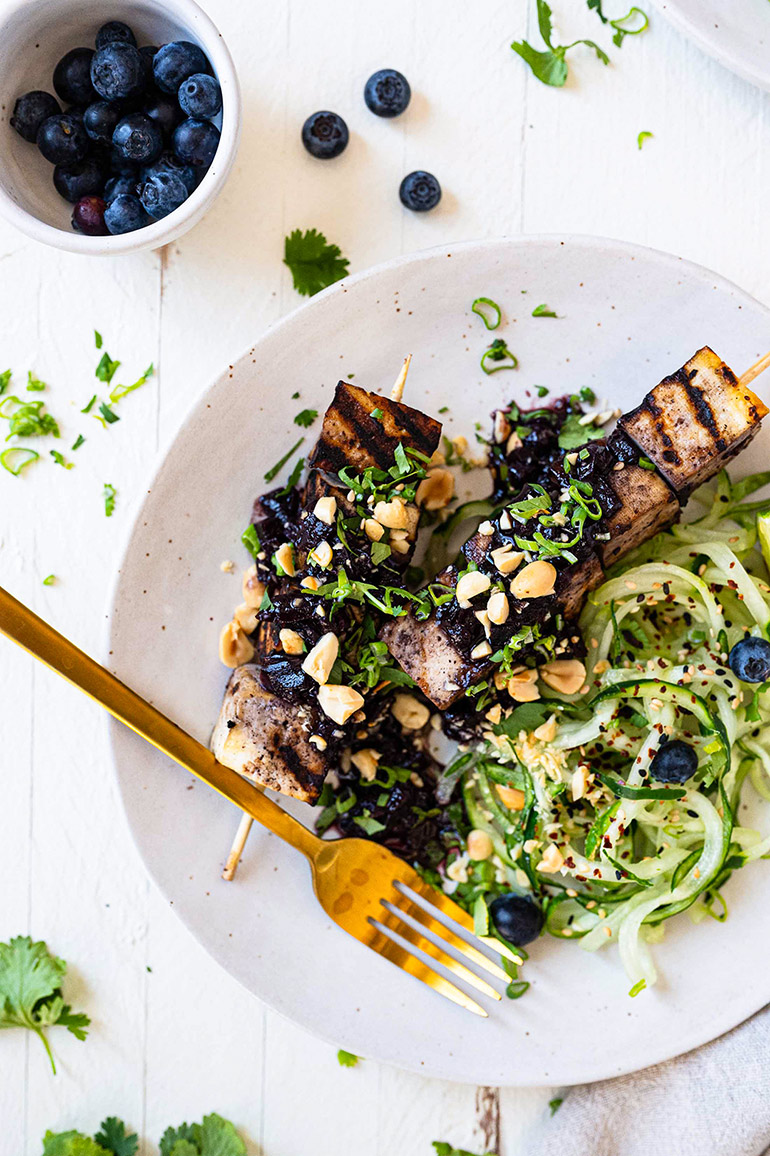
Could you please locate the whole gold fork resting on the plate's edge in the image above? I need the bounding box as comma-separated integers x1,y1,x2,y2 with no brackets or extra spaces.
0,587,521,1016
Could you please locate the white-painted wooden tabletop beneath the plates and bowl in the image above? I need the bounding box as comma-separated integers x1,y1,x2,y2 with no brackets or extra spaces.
0,0,770,1156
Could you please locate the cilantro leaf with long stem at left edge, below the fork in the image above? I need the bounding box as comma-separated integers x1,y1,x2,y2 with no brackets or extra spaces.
0,935,90,1073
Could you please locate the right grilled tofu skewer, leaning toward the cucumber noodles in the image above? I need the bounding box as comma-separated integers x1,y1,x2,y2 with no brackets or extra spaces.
382,347,768,710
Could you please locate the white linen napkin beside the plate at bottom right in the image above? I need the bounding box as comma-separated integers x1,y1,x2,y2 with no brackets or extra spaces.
524,1003,770,1156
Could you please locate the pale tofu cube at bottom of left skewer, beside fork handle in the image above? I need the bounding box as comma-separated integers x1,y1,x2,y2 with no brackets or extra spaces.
210,665,327,802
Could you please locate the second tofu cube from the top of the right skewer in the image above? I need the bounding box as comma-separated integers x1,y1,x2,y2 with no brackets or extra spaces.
597,461,681,566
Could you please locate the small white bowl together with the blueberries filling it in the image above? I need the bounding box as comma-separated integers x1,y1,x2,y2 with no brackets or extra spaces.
0,0,240,254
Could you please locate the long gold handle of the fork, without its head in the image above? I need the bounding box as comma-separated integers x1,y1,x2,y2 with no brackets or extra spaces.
0,586,324,859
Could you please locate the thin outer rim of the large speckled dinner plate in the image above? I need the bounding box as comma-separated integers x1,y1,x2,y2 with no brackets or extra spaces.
104,234,770,1087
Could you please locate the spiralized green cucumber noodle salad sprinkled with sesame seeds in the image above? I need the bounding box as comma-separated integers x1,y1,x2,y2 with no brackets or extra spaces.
434,472,770,996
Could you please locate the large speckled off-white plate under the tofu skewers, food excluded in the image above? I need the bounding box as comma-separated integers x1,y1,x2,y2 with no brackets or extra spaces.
109,237,770,1085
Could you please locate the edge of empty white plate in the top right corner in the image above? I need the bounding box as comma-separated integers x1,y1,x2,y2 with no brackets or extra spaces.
652,0,770,89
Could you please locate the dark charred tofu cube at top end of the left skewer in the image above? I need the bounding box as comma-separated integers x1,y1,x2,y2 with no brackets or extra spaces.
309,381,442,474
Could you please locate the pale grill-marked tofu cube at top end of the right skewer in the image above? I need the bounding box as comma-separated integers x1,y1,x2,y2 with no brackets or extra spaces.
619,346,768,501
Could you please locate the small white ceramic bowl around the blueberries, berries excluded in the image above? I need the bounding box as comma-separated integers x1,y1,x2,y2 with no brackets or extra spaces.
0,0,240,255
